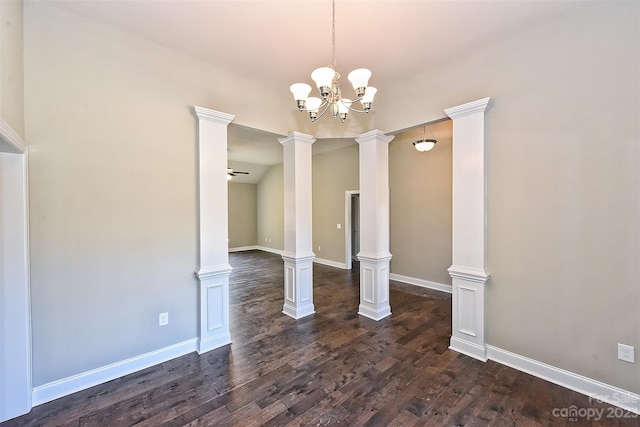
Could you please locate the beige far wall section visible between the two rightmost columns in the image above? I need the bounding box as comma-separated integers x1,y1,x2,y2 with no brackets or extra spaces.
389,120,452,285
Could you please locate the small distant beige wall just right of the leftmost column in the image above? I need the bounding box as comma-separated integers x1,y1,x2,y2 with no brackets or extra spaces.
229,182,258,248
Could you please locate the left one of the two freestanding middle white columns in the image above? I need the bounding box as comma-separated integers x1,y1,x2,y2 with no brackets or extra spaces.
278,132,316,319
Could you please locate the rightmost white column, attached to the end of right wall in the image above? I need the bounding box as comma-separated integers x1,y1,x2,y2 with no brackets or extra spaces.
445,98,490,361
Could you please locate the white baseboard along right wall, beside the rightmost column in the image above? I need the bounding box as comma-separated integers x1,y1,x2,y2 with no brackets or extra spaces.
486,345,640,414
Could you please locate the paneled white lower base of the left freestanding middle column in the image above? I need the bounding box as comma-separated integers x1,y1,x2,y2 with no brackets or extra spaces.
282,252,316,319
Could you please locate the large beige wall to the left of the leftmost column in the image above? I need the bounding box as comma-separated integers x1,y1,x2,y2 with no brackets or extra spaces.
24,2,202,386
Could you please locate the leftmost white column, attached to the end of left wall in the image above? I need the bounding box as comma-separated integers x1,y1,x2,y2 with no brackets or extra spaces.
195,107,235,354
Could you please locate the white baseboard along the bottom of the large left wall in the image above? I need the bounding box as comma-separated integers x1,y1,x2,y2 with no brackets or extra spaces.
32,338,197,406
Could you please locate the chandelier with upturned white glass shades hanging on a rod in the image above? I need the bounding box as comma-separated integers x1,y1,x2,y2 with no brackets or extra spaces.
289,0,378,123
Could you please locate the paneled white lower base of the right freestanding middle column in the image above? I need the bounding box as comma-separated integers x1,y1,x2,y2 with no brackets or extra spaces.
358,252,391,320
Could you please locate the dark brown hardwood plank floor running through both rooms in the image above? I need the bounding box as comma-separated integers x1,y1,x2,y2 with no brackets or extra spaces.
0,251,640,427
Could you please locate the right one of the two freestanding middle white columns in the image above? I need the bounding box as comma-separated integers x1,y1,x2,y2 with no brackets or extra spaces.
356,130,393,320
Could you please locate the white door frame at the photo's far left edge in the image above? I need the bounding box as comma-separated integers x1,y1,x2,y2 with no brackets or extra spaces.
0,117,33,422
